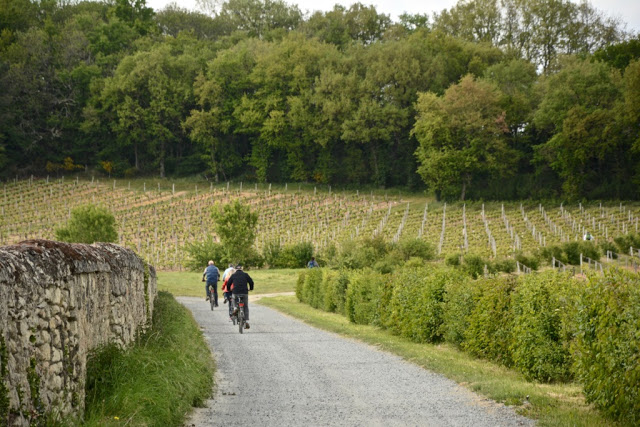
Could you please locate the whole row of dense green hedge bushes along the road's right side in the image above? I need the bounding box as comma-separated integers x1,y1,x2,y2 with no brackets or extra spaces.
296,266,640,425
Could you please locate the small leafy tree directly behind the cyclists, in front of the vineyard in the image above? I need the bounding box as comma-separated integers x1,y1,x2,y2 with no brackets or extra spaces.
211,200,258,263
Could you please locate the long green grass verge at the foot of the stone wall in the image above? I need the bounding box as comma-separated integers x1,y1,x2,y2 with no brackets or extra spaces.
85,292,215,426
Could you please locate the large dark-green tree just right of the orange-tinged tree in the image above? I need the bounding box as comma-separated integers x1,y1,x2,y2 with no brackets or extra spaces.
533,58,633,197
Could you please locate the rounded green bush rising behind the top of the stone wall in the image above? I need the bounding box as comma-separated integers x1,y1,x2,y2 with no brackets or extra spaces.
56,205,118,243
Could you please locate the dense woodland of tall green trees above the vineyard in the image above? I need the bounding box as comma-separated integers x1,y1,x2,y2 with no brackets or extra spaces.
0,0,640,199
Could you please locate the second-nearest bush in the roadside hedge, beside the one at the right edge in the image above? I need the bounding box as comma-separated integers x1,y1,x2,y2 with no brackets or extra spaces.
511,272,573,382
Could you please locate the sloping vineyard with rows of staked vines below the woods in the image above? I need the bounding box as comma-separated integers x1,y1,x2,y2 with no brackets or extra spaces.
0,178,640,270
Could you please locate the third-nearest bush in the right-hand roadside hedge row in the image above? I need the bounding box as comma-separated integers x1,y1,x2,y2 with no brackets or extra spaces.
462,277,515,366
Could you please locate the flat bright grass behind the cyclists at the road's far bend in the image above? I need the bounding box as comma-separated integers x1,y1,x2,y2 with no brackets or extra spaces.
157,269,300,298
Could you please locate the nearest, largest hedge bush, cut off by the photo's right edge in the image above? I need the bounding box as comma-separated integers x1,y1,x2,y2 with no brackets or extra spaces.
573,270,640,425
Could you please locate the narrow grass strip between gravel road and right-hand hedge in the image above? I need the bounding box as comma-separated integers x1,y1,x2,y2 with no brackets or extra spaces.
260,296,616,426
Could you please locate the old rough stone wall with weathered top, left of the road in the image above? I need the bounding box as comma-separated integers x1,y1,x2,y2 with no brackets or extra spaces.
0,240,157,426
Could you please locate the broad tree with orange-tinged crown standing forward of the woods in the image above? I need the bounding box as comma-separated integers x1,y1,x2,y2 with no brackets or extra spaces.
412,75,517,200
